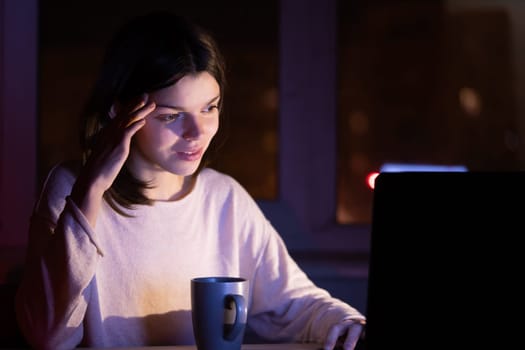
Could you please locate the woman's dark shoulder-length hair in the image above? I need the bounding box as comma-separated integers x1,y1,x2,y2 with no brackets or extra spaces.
81,12,226,215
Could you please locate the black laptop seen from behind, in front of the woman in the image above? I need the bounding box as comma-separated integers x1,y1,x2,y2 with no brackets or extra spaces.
358,171,525,350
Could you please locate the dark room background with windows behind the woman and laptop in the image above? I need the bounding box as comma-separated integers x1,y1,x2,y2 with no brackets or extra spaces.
0,0,525,342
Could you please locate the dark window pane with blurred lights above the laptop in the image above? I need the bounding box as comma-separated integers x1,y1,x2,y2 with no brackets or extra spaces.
337,0,519,223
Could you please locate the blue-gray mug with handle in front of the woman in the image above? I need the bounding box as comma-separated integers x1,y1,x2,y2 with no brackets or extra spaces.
191,276,249,350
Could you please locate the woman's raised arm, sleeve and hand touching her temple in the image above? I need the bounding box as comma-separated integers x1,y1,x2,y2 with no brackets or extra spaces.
16,96,155,349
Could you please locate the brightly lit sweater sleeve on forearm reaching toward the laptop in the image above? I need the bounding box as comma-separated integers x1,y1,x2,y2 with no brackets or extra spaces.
250,222,365,343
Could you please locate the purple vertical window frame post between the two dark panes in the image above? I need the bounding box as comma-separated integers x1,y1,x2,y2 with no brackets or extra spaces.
258,0,370,266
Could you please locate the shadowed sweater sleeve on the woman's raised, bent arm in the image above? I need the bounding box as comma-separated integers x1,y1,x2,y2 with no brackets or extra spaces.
16,168,102,349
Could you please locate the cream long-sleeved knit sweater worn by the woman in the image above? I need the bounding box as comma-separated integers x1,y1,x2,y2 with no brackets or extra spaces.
13,165,363,350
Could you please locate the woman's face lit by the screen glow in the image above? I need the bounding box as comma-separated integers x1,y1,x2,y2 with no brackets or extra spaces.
130,72,220,179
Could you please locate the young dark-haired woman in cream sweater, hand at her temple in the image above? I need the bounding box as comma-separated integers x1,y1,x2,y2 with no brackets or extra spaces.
16,13,364,349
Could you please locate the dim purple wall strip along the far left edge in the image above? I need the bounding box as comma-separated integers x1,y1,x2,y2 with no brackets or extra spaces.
0,0,37,346
